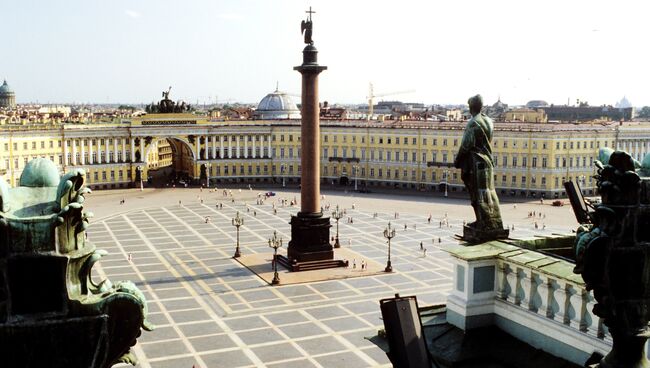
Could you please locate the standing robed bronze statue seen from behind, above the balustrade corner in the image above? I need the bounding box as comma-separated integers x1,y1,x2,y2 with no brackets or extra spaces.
454,95,508,243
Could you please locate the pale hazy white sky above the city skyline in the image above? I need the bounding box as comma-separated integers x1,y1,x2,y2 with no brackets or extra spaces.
0,0,650,106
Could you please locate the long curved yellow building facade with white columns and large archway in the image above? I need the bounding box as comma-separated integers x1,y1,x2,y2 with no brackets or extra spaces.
0,114,650,198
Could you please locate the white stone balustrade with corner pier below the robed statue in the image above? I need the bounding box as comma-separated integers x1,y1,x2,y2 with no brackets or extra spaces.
446,237,612,364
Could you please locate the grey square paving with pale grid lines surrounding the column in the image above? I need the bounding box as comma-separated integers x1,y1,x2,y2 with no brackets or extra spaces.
89,188,566,368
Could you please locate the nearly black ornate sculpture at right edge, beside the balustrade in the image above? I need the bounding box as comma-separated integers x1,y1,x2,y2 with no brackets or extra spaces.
574,148,650,368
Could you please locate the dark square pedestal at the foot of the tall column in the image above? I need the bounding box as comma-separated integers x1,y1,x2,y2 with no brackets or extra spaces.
287,212,334,263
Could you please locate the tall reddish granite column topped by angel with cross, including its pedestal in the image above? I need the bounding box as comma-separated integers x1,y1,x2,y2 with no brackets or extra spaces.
287,7,334,264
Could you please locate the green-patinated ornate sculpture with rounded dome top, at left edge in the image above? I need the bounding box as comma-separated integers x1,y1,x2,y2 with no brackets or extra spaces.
0,158,153,368
